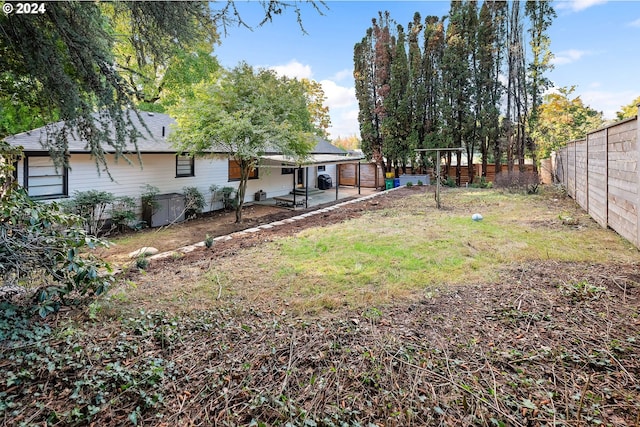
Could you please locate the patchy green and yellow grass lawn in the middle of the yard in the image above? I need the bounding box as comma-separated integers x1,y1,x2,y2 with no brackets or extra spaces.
124,189,638,314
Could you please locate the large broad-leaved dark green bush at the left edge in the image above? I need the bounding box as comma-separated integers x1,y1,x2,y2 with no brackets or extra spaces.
0,188,113,317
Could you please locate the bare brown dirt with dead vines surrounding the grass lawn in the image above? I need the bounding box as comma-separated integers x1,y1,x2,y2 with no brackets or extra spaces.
0,188,640,427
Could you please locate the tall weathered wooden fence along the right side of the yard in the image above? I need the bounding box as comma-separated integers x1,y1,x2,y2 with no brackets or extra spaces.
553,116,640,248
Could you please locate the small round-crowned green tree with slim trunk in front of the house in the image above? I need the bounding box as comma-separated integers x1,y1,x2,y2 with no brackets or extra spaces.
170,63,317,223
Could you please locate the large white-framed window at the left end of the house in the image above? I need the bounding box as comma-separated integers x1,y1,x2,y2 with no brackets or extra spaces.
24,156,69,199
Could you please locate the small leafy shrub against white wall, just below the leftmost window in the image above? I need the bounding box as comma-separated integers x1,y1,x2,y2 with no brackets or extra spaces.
64,190,116,236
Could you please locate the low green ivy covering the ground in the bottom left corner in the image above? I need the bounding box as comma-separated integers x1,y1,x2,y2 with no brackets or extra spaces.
0,310,178,425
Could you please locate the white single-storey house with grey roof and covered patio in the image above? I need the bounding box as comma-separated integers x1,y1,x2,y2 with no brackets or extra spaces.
6,112,361,221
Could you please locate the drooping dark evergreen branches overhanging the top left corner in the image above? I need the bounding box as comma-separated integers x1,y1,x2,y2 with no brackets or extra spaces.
0,0,323,166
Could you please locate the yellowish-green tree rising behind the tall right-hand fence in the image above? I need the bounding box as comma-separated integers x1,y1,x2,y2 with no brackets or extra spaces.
532,86,604,159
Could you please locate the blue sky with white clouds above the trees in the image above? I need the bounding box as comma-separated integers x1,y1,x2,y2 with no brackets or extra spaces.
214,0,640,138
